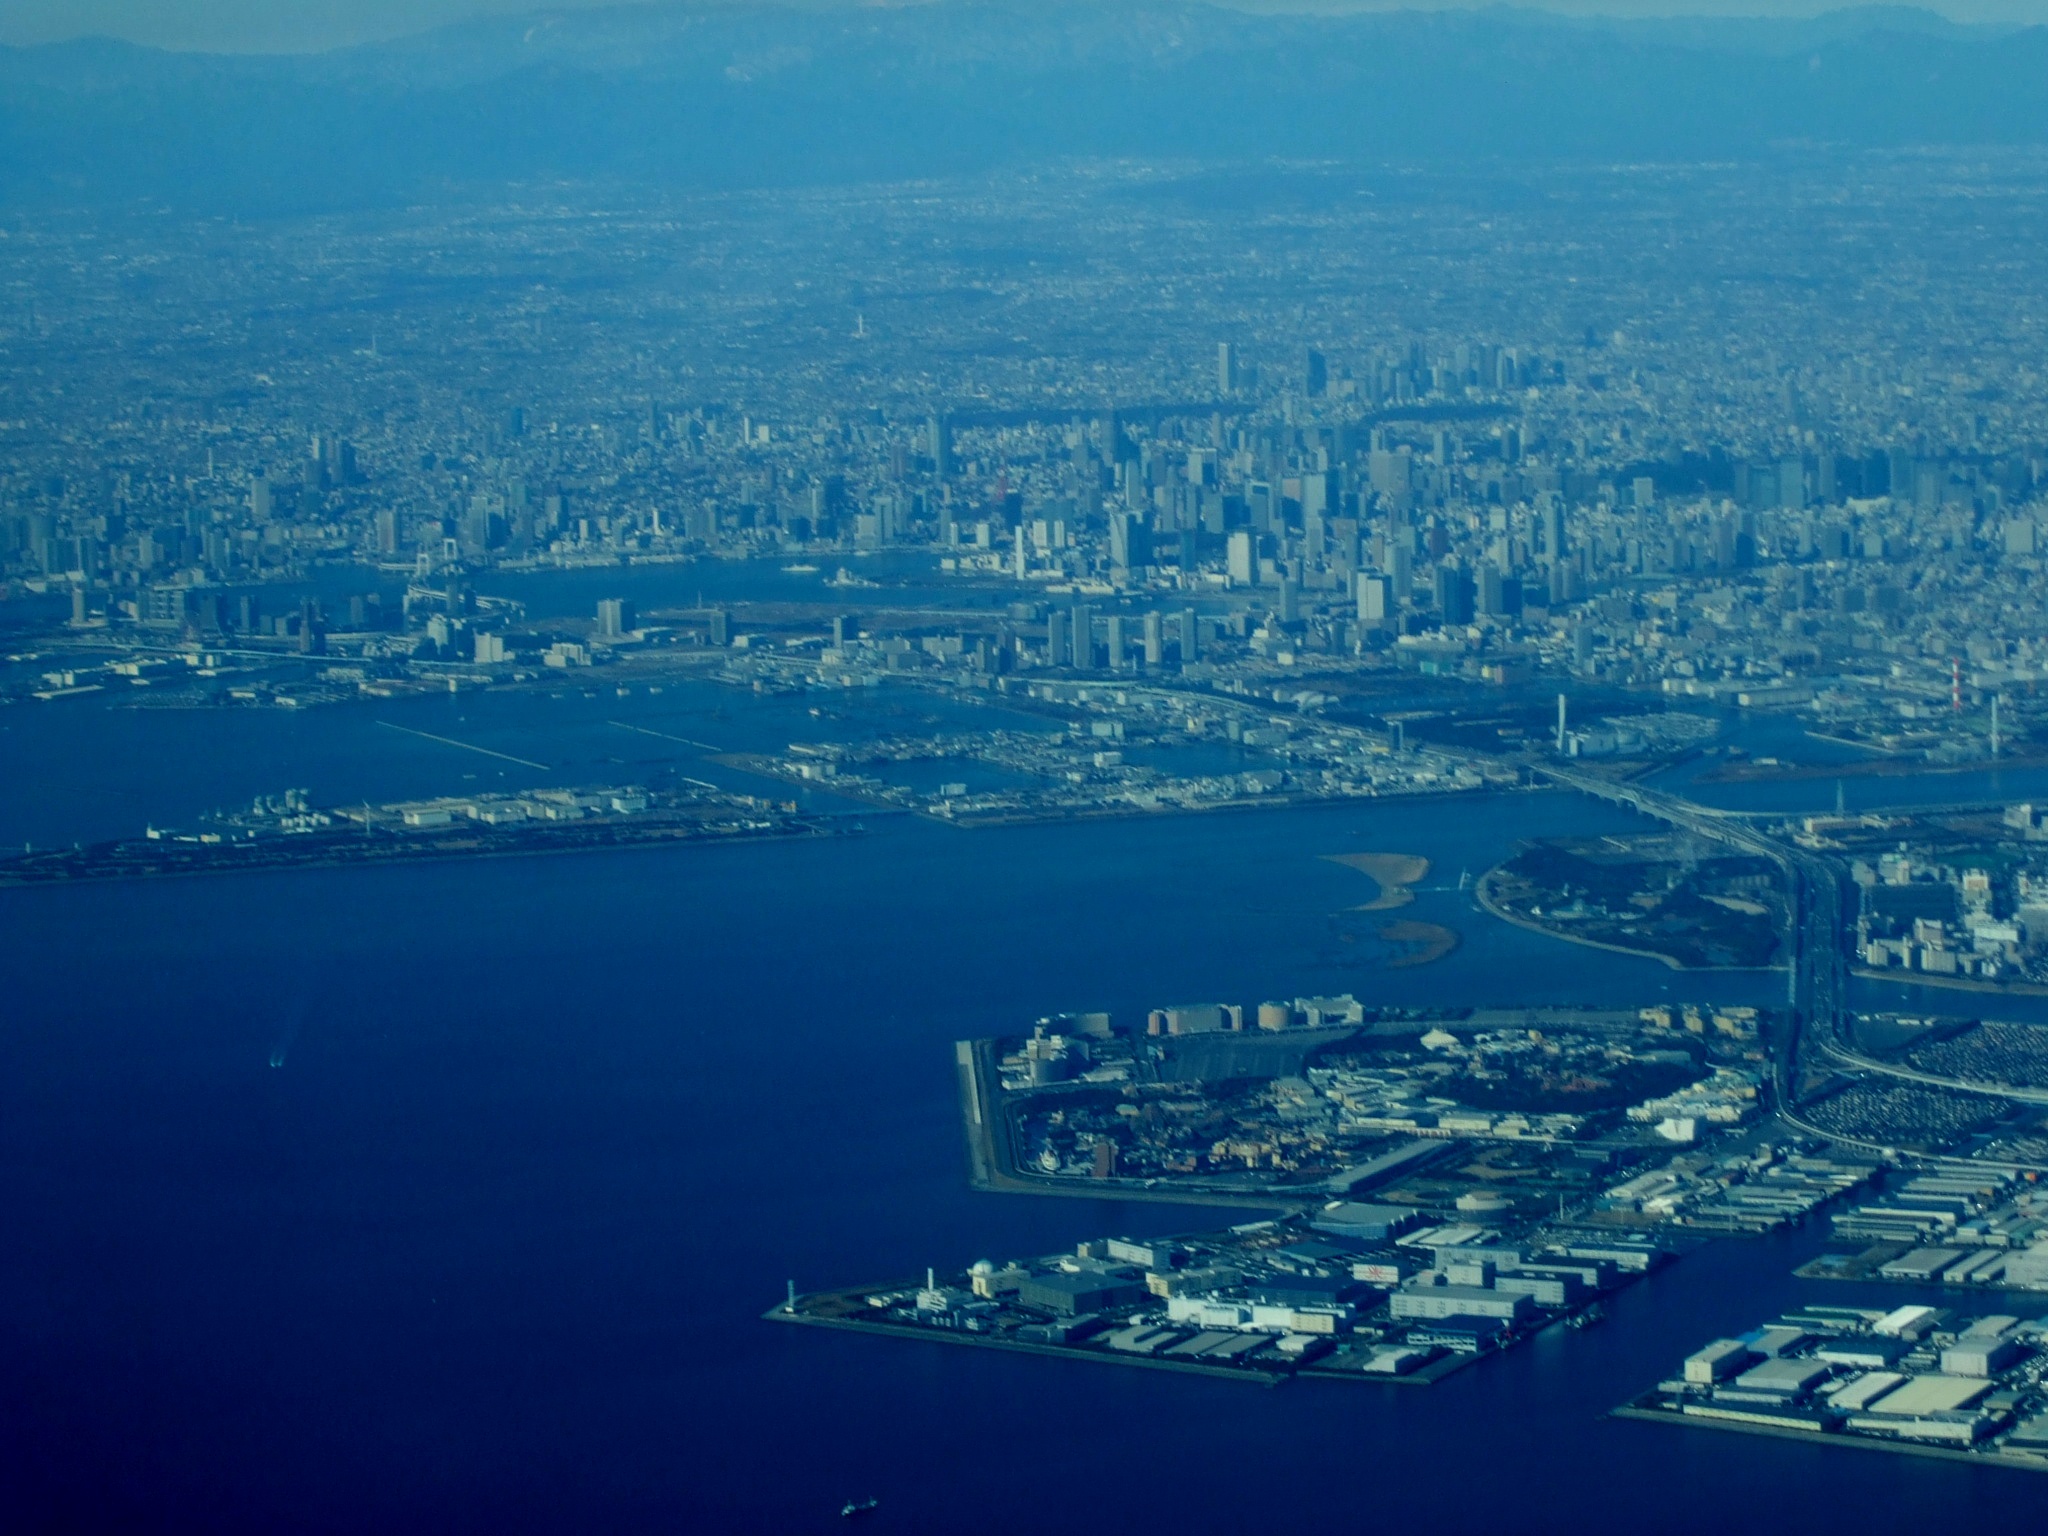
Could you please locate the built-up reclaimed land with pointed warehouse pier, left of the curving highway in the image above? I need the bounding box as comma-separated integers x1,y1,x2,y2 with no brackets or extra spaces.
768,995,1826,1382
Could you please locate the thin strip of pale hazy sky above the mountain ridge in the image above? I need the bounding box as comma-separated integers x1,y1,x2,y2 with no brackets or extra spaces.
0,0,2048,51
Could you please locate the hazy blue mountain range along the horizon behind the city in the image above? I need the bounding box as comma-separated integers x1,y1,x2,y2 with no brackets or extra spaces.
0,0,2048,211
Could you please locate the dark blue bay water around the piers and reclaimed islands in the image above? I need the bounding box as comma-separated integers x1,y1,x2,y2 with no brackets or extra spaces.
0,692,2044,1536
